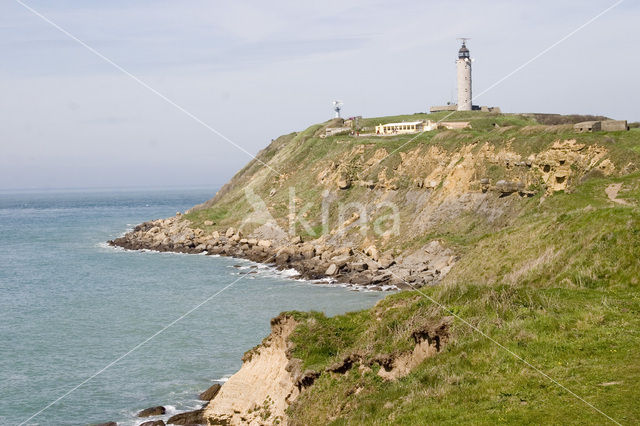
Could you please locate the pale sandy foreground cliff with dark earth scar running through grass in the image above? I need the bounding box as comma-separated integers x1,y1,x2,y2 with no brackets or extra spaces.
199,313,452,425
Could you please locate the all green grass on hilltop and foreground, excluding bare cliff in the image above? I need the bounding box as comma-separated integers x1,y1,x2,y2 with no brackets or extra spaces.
188,113,640,424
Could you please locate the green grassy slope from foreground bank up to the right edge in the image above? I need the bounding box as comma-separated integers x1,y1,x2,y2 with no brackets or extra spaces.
291,174,640,424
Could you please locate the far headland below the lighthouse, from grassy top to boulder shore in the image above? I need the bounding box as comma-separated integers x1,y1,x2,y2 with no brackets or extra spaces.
114,112,638,288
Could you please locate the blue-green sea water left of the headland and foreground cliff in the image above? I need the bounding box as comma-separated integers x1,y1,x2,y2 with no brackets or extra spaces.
0,190,383,425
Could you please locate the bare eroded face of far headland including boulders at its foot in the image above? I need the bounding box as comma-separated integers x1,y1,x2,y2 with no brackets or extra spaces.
112,135,616,289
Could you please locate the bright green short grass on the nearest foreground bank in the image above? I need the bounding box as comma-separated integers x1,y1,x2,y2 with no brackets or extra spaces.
290,285,640,425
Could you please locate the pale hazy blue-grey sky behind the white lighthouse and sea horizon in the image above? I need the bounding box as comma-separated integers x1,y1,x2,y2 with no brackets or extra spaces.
0,0,640,190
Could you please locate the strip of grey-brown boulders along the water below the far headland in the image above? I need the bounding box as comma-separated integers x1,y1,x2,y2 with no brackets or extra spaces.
108,213,457,290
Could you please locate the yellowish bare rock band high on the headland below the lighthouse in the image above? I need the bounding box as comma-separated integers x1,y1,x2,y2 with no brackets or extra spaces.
315,139,615,198
